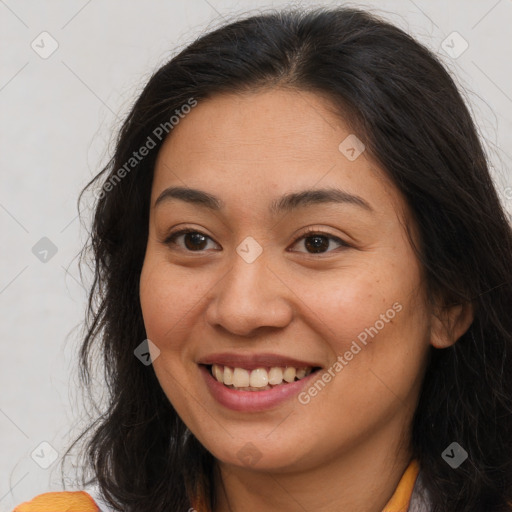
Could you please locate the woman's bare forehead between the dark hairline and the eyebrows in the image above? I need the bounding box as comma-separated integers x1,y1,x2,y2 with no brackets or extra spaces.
152,89,401,220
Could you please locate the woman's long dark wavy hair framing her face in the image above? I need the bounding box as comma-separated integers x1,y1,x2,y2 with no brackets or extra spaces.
62,8,512,512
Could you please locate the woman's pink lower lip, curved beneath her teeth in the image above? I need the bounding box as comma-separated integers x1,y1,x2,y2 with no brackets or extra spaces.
199,365,318,412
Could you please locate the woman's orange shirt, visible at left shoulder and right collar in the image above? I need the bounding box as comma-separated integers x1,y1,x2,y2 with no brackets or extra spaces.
13,460,419,512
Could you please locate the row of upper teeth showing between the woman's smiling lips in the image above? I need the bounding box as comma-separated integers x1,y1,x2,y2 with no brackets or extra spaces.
205,364,320,391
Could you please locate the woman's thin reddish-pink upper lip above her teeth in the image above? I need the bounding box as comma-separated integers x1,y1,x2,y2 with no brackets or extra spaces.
198,352,320,370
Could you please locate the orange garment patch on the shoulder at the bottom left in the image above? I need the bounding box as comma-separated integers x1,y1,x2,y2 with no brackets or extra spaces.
12,491,102,512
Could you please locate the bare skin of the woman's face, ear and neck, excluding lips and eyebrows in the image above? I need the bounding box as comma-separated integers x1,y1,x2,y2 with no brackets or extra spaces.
140,88,472,512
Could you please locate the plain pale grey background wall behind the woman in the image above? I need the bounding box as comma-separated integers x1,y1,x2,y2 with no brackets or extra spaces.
0,0,512,511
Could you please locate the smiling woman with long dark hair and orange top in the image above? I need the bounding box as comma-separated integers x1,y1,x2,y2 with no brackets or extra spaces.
13,8,512,512
